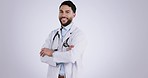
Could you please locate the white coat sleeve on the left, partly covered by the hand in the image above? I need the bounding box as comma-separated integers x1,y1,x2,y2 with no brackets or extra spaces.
40,32,56,66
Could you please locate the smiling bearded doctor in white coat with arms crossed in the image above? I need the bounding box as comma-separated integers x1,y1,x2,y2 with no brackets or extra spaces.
40,1,86,78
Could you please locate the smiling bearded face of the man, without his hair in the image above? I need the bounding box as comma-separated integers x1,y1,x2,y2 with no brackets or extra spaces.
59,5,76,26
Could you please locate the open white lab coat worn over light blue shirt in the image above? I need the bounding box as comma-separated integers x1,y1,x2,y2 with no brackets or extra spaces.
41,25,86,78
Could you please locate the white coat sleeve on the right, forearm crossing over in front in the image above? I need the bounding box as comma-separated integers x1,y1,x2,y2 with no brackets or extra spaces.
53,33,86,63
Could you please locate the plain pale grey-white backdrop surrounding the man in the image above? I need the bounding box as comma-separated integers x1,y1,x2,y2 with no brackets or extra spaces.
0,0,148,78
